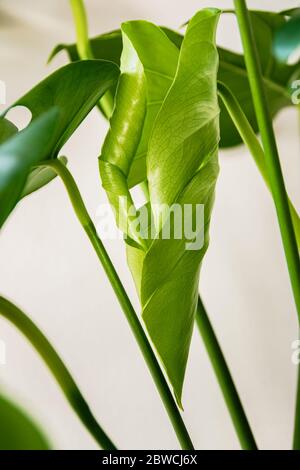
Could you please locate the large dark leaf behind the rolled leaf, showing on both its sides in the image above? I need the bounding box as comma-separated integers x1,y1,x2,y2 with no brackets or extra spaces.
52,11,297,147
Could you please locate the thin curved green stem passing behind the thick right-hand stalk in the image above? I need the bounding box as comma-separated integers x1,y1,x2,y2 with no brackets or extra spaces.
218,82,300,250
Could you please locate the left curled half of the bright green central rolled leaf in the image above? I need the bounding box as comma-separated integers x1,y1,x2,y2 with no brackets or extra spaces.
99,21,179,246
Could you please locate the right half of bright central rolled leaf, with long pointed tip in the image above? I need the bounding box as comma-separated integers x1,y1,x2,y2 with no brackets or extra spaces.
127,9,220,404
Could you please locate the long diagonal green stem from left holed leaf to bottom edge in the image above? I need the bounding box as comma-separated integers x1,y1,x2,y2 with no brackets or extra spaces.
41,160,193,450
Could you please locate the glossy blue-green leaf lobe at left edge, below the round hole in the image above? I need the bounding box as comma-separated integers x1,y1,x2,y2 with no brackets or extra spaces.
0,108,59,227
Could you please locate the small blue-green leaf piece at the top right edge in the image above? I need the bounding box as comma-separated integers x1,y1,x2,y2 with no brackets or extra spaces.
274,12,300,62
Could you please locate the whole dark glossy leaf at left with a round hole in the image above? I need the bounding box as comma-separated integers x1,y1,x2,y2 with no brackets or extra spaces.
0,60,119,227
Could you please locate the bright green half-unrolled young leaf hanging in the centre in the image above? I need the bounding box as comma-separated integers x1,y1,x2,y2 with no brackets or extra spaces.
100,9,220,405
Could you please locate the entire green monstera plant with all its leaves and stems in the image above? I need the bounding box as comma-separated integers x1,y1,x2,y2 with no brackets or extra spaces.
0,0,300,450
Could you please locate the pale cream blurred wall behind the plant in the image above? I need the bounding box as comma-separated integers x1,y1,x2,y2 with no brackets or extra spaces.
0,0,300,449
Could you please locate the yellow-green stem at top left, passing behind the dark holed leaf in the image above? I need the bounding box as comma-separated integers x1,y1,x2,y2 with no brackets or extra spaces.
70,0,114,118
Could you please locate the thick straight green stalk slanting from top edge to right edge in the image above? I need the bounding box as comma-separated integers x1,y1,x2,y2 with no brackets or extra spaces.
234,0,300,449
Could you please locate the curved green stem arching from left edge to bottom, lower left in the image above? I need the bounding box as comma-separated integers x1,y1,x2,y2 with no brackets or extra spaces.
0,297,116,450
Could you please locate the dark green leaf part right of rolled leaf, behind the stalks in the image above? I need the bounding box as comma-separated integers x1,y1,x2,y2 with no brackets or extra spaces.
218,11,296,147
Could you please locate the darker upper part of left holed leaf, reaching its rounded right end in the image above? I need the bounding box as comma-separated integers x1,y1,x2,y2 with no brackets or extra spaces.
6,60,119,158
